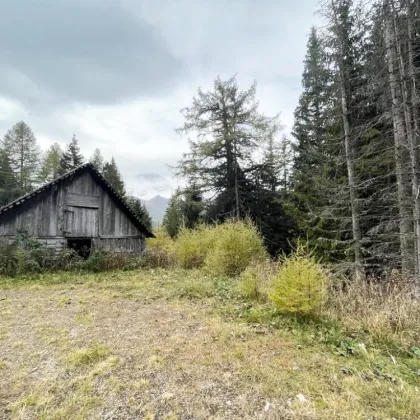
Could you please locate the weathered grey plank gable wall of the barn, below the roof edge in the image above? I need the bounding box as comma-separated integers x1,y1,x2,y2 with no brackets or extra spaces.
0,172,145,252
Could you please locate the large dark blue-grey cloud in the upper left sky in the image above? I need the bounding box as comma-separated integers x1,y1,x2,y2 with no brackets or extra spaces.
0,0,182,109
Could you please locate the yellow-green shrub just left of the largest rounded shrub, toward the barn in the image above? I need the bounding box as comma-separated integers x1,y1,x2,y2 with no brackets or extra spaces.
174,225,214,268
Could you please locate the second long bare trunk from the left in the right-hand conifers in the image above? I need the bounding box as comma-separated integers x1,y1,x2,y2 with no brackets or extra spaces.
385,13,413,273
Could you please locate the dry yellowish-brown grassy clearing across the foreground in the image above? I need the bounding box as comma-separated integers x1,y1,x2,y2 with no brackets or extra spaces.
0,270,420,419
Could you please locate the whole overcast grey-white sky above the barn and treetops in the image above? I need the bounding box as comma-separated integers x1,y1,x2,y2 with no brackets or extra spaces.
0,0,317,198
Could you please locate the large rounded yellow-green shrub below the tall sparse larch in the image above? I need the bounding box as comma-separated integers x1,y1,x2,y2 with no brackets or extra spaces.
204,221,266,276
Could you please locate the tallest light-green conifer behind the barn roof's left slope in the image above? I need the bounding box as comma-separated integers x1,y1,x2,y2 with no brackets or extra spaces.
3,121,40,193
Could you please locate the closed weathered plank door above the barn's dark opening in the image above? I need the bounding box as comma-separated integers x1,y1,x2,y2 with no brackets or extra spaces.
64,194,99,238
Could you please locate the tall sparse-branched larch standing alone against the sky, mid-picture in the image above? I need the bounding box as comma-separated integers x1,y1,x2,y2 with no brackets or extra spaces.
177,77,277,219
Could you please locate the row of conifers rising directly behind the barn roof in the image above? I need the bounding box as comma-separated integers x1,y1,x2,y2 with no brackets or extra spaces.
0,126,152,230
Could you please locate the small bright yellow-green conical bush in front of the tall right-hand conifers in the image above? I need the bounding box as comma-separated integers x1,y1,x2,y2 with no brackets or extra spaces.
270,246,328,315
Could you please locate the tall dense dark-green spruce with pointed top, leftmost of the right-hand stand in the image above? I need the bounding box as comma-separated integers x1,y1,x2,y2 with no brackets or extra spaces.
288,28,343,260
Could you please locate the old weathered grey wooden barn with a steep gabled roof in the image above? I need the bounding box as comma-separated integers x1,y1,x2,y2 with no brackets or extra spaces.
0,163,153,253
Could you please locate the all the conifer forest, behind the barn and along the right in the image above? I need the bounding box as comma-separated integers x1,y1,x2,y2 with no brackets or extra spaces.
0,0,420,277
